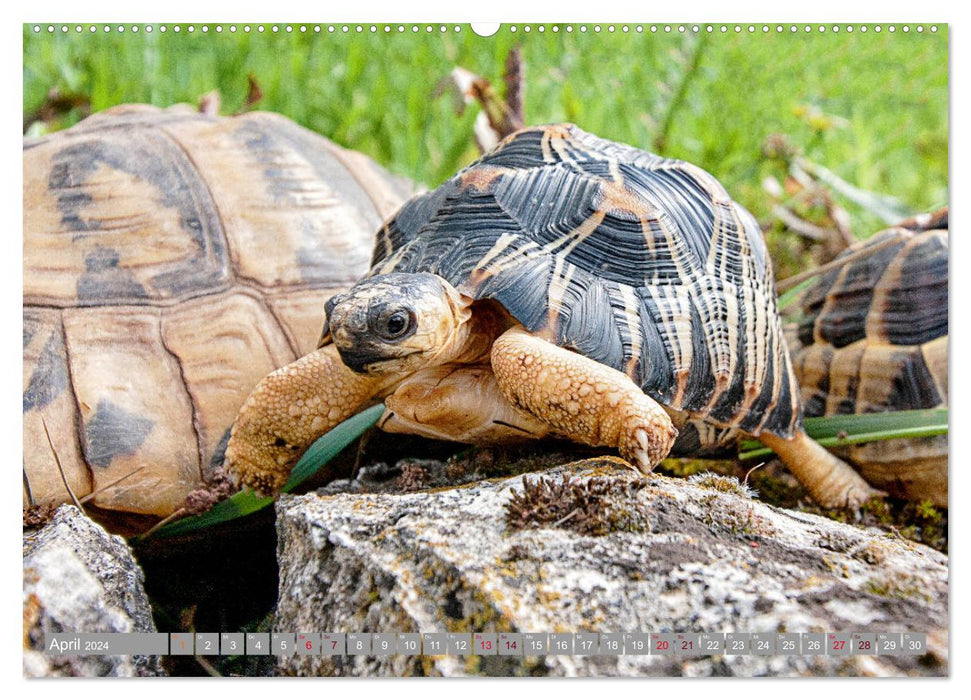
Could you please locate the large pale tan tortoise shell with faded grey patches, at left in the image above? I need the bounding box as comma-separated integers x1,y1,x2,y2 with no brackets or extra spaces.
23,105,410,516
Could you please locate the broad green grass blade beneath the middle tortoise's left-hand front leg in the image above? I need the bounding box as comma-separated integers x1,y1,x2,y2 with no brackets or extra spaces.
152,404,384,537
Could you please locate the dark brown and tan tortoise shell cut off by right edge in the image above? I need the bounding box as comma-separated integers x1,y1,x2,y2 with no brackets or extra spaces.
793,209,948,505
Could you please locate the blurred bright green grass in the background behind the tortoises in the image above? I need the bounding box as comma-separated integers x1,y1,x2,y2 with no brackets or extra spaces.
24,25,948,243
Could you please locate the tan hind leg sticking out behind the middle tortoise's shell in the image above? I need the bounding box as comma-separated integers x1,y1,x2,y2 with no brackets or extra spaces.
759,430,883,508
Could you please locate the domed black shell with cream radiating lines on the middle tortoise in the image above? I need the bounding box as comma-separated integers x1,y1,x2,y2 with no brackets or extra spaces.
370,124,801,449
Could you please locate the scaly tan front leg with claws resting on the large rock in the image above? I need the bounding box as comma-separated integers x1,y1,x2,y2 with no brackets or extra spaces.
492,327,678,474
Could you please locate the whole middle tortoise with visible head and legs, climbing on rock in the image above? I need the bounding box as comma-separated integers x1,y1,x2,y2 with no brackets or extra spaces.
226,124,874,505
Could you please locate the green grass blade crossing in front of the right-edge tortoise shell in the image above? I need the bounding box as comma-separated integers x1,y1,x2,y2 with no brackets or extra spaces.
738,408,948,459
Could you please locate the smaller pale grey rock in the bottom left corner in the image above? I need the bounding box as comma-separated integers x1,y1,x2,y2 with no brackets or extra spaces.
23,506,164,677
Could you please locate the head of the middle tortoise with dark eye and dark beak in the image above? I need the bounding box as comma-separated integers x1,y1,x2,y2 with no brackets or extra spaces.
324,273,471,374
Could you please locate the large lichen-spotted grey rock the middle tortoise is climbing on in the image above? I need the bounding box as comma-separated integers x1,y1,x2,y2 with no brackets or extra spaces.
275,460,948,676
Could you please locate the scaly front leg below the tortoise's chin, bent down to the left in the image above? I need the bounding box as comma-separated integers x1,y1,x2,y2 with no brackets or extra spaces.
225,345,382,493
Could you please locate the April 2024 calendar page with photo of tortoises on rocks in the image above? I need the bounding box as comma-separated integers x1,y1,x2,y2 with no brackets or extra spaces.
22,7,950,679
